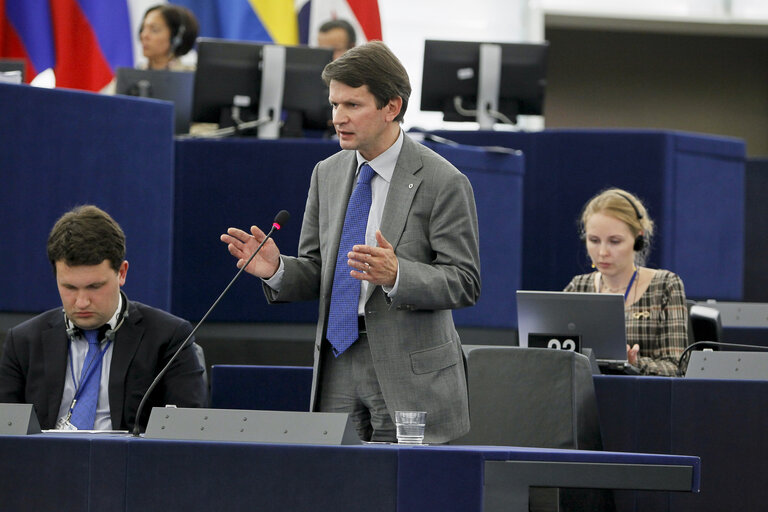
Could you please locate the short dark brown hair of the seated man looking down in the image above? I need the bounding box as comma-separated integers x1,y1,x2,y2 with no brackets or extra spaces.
47,205,125,274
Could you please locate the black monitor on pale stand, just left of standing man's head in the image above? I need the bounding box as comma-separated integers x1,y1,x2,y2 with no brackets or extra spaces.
192,38,333,138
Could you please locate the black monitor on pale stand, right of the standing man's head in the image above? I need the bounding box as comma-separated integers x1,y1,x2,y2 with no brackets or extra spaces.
421,40,549,129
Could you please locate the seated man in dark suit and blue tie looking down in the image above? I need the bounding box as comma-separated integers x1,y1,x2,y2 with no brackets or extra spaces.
0,206,207,430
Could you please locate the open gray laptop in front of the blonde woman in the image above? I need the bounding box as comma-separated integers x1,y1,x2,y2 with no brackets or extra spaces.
517,290,637,373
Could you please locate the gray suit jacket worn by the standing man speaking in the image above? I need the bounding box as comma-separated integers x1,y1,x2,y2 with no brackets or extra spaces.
267,135,480,443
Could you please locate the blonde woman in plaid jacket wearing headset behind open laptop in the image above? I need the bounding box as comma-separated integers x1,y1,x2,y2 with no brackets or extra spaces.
565,188,688,376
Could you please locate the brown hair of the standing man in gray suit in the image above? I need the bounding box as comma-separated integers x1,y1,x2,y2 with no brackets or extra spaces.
323,41,411,122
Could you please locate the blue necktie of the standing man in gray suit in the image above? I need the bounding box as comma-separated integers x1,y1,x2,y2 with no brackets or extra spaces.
327,163,375,357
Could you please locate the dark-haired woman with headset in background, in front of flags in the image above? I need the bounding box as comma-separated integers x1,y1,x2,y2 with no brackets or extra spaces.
139,4,199,71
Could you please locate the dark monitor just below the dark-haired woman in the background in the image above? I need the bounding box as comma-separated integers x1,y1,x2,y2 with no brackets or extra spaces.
116,67,195,134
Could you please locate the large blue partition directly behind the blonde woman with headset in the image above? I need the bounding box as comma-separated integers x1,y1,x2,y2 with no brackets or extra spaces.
426,130,746,300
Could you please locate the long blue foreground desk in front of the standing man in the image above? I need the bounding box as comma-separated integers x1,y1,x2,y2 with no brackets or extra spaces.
0,434,701,512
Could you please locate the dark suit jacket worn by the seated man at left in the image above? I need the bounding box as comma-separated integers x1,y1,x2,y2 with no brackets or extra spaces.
0,301,208,430
